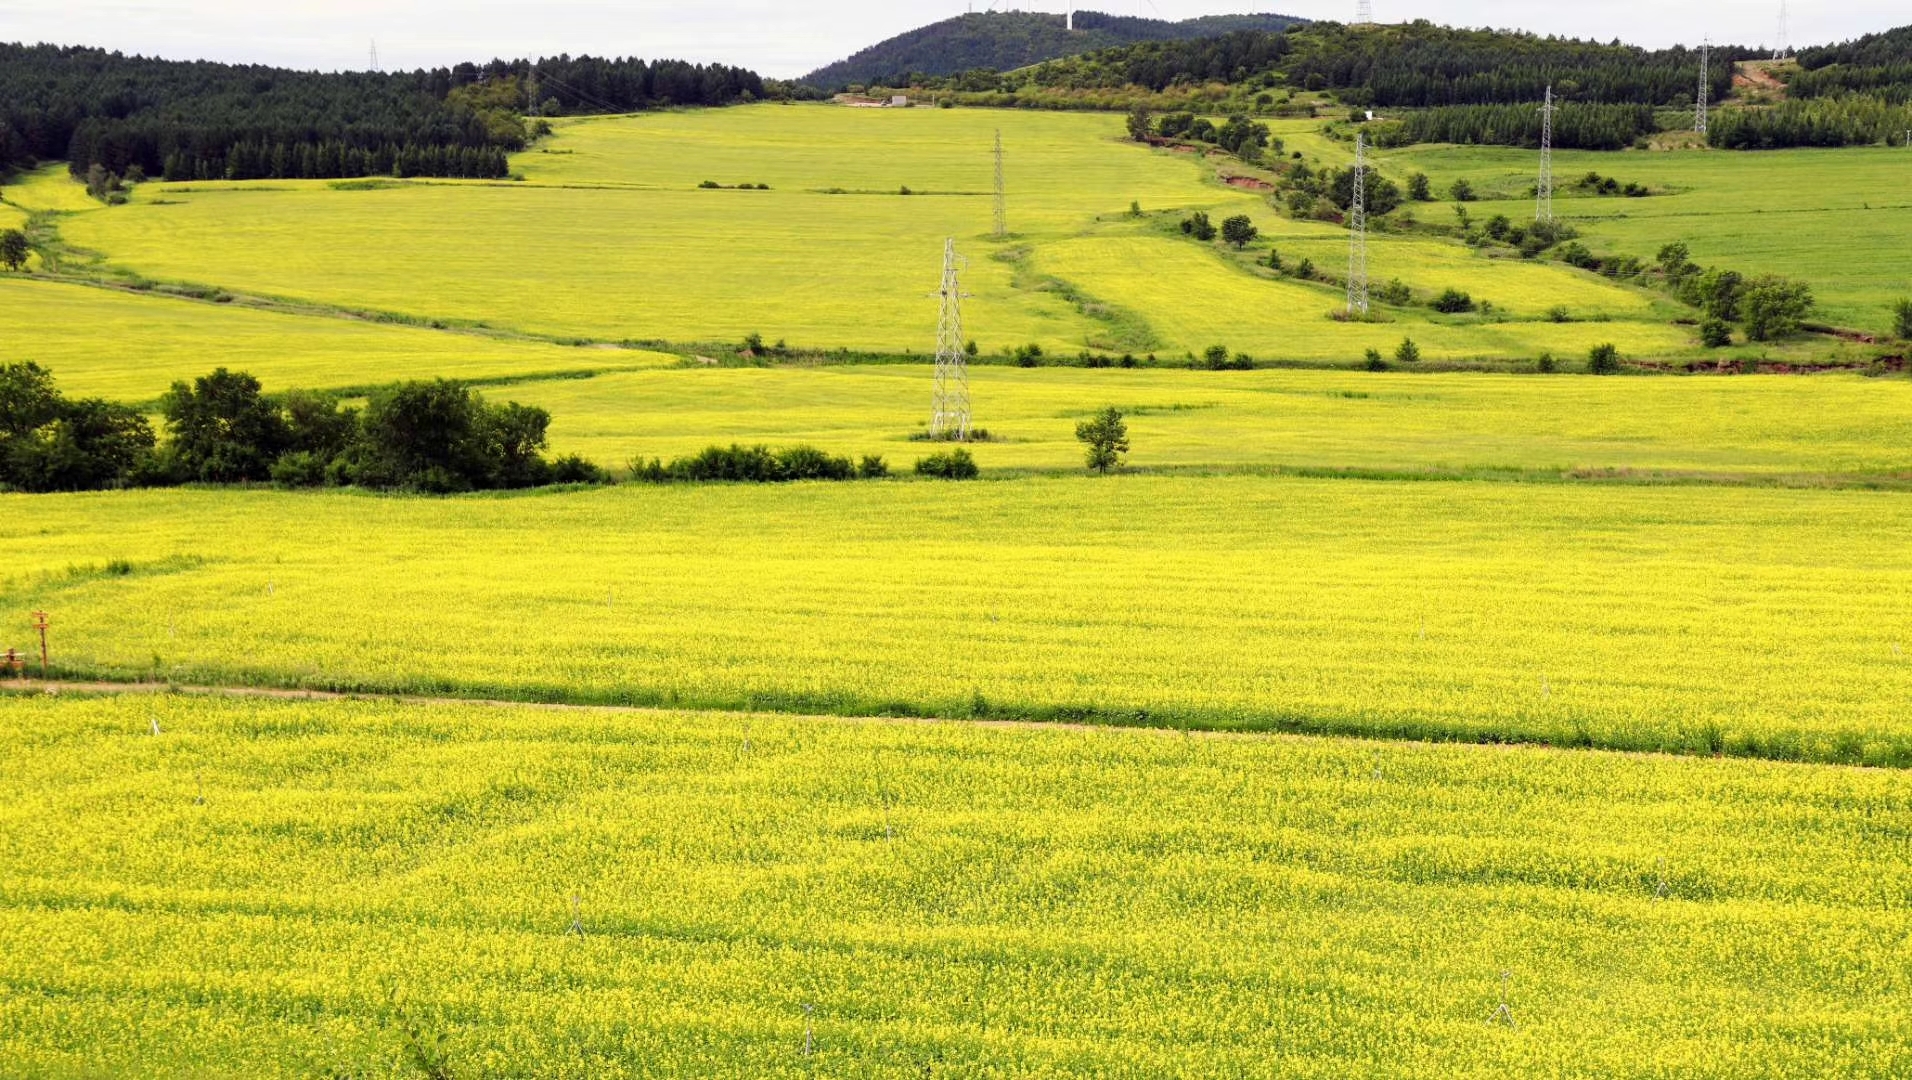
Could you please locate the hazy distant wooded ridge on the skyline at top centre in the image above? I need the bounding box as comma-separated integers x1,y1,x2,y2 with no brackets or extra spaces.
803,11,1306,90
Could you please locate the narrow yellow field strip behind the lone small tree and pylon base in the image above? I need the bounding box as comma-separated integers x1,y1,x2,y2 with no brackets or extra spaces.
508,365,1912,480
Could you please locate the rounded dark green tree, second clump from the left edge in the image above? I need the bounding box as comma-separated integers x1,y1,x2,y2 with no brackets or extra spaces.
161,367,287,484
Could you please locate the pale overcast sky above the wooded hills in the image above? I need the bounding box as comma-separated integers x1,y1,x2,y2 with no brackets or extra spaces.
0,0,1912,78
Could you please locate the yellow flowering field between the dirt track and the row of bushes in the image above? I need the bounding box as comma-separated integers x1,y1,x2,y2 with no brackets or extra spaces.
14,476,1912,763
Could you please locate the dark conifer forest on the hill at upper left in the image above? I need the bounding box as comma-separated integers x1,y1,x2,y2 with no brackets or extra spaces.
0,44,765,180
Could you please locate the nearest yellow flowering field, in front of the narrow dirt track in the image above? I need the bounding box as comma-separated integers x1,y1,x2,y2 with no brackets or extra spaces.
0,696,1912,1080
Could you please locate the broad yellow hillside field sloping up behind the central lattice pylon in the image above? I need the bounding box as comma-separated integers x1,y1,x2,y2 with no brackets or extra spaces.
29,105,1692,361
